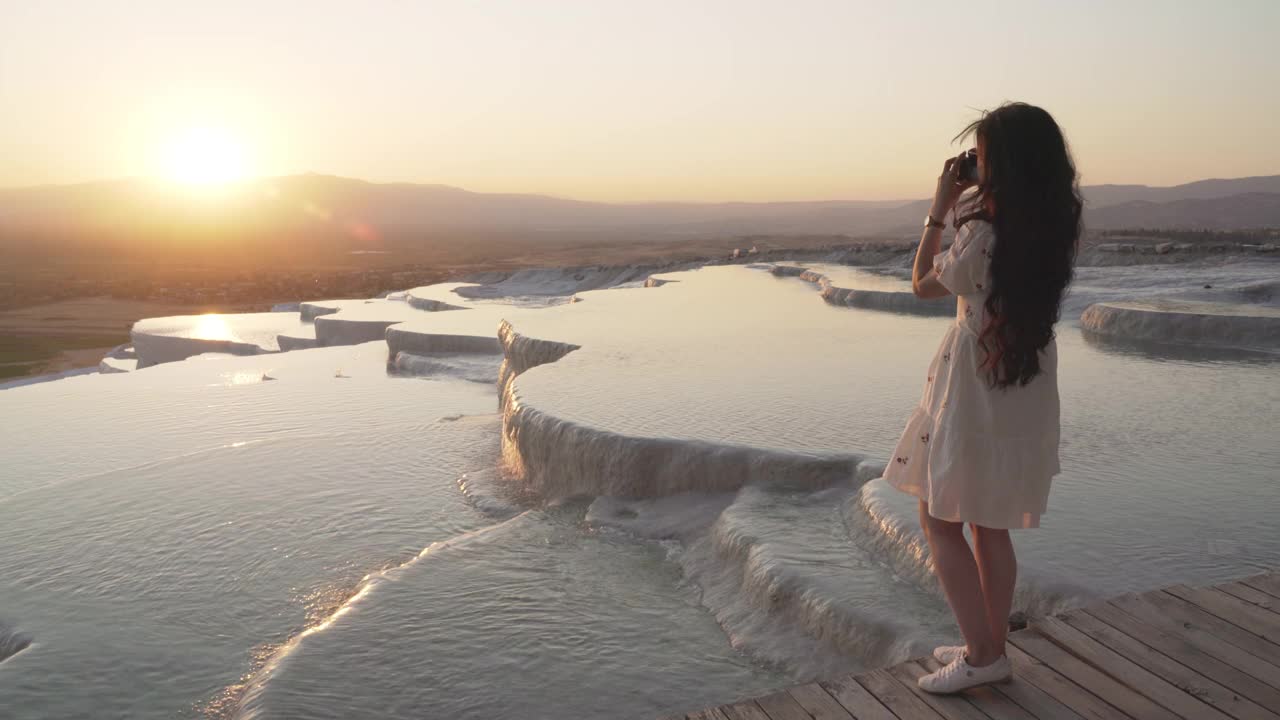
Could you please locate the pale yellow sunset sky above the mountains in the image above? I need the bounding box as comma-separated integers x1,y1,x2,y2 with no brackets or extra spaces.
0,0,1280,201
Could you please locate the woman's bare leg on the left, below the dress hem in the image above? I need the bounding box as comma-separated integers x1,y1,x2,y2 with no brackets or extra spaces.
920,501,1005,667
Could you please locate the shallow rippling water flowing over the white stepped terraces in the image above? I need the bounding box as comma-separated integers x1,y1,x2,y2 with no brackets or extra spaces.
0,258,1280,719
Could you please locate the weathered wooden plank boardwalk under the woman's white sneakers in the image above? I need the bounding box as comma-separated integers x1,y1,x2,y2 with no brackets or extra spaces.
684,573,1280,720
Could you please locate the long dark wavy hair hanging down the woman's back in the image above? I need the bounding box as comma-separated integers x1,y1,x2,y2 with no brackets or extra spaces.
956,102,1084,388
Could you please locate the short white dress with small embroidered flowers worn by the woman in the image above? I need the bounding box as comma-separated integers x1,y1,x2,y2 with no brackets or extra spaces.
884,220,1060,528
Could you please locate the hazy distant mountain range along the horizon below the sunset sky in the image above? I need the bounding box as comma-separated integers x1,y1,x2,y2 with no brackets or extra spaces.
0,174,1280,243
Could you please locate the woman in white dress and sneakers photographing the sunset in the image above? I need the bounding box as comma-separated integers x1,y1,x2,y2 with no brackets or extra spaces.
884,102,1083,693
